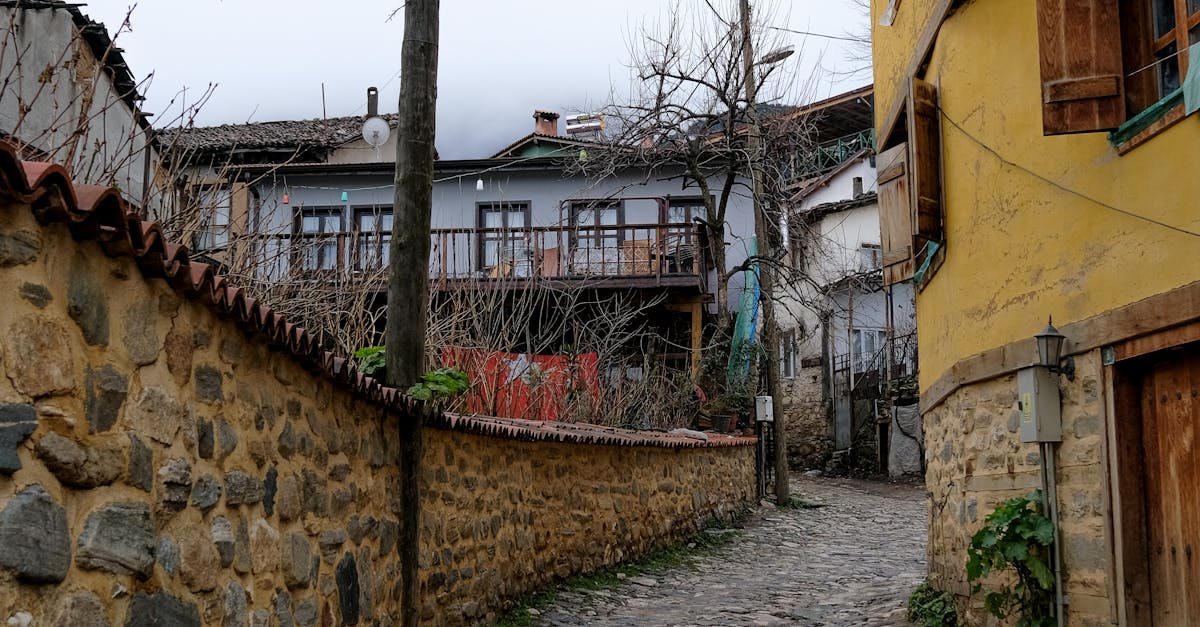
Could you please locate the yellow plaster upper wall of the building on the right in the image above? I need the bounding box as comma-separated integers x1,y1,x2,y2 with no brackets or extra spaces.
875,0,1200,390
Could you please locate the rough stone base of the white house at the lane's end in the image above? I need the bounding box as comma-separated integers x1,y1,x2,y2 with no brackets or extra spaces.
779,357,834,468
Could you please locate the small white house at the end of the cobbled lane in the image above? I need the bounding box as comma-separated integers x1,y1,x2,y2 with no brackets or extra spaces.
778,149,919,471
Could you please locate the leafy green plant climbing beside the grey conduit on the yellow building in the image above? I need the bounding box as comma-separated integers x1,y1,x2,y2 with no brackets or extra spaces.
967,490,1055,627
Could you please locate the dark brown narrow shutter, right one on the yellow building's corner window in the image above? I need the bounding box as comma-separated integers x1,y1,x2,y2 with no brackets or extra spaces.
907,78,943,245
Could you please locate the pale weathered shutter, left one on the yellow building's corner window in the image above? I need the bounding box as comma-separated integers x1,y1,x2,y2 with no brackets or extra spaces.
876,143,916,285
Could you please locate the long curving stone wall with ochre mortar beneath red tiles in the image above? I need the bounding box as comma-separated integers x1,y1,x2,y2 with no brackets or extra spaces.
0,154,755,626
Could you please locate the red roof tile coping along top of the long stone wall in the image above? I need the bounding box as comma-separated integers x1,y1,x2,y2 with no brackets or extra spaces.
0,142,755,448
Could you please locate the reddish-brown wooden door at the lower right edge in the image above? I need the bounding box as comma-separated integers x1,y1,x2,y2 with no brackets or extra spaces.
1141,344,1200,626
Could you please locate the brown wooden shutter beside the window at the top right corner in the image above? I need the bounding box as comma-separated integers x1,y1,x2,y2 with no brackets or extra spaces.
1038,0,1124,135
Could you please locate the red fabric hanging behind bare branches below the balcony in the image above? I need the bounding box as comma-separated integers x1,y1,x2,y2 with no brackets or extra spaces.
442,347,600,420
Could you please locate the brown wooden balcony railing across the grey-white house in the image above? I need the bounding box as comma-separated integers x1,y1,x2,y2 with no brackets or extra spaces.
222,223,709,289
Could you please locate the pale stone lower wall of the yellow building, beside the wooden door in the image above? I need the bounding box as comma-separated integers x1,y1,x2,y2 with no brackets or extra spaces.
924,351,1115,626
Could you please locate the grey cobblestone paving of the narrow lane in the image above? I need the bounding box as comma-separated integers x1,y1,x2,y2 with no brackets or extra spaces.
534,476,925,627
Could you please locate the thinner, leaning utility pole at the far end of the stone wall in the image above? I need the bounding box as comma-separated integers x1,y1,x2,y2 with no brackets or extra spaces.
742,0,791,504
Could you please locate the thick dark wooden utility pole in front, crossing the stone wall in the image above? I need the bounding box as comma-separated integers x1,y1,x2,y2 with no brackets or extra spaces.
386,0,439,627
